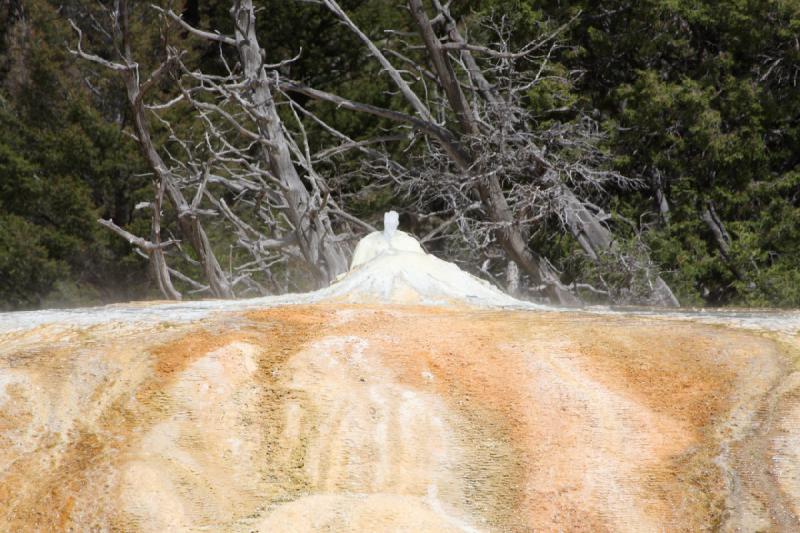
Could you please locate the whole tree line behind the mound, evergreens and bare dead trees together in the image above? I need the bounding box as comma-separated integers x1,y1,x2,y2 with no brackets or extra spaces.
0,0,800,309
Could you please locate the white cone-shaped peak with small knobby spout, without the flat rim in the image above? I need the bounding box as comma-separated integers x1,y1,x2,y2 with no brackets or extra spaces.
318,211,529,306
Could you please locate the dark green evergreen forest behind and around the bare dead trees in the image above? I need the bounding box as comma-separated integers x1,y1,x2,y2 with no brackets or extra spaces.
0,0,800,310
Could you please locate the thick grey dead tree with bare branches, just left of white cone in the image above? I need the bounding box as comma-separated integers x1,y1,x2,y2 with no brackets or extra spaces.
159,0,352,286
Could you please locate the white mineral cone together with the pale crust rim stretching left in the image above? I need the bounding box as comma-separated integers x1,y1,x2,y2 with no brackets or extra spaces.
0,211,532,333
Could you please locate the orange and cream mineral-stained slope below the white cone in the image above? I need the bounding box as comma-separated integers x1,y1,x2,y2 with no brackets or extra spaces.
0,302,800,532
